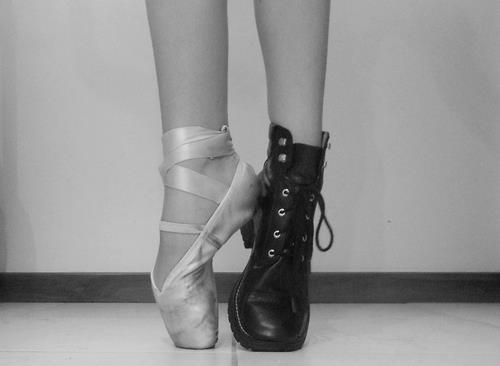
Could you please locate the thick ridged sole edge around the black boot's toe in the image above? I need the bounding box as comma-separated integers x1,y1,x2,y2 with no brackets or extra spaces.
227,277,305,352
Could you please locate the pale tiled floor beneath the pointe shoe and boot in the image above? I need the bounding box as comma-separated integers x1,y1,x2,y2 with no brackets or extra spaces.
0,304,500,366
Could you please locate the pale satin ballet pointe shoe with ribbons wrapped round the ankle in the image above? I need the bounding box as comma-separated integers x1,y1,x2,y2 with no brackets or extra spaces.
151,126,259,349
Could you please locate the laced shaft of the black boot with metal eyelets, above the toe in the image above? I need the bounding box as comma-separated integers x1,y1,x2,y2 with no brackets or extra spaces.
253,124,329,273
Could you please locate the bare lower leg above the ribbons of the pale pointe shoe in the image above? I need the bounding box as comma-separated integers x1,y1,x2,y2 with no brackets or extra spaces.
146,0,228,131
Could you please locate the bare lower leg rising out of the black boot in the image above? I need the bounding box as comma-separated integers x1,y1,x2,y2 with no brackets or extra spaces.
254,0,330,146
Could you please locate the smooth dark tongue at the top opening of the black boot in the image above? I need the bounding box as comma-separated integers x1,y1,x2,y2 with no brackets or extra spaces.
288,143,321,184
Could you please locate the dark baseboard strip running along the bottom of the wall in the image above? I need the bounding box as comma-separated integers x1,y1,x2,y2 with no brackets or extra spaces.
0,272,500,303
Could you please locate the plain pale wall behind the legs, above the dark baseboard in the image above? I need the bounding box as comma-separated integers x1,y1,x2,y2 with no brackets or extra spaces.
0,0,500,272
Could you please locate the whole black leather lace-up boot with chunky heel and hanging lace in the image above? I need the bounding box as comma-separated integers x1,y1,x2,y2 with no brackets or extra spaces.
228,124,333,351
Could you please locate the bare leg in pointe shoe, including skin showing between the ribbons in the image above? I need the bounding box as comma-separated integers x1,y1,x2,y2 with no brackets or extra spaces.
146,0,236,286
